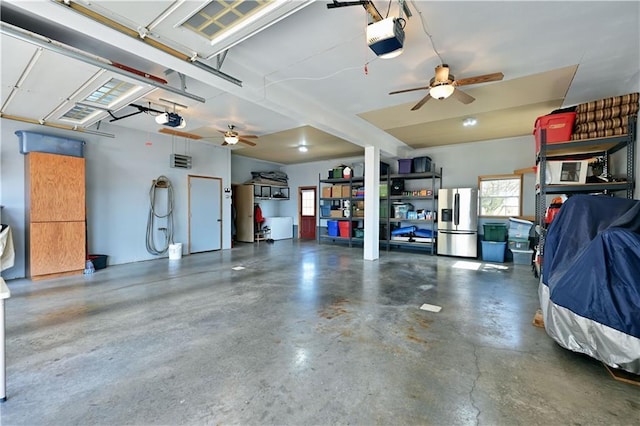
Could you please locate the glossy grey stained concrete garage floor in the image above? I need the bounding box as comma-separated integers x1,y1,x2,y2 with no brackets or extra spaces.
1,240,640,425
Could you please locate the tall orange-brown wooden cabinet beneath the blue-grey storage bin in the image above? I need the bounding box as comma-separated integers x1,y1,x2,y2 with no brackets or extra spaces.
25,152,86,280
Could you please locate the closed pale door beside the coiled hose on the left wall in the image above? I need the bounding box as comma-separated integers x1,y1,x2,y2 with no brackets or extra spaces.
189,176,222,253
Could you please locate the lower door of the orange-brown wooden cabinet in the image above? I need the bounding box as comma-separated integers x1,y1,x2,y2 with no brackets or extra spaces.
29,221,86,277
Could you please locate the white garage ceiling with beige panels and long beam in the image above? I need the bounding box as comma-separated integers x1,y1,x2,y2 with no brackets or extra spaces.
0,0,640,164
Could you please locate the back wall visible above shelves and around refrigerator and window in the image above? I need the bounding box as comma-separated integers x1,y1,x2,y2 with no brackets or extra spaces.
281,136,535,224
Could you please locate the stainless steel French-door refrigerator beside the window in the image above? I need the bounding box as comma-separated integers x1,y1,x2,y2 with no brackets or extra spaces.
438,188,478,258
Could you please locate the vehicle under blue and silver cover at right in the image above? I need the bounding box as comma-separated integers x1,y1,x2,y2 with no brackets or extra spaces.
538,195,640,374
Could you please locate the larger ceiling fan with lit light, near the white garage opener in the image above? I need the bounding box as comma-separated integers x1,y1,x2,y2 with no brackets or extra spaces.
389,64,504,111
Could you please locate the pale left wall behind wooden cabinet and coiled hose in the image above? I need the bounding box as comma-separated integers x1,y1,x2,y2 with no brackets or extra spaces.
0,119,231,278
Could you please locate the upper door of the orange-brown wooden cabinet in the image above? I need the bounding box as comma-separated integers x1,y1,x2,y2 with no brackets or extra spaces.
26,152,85,220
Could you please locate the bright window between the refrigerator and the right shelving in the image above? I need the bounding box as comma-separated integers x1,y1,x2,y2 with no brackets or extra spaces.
478,175,522,217
